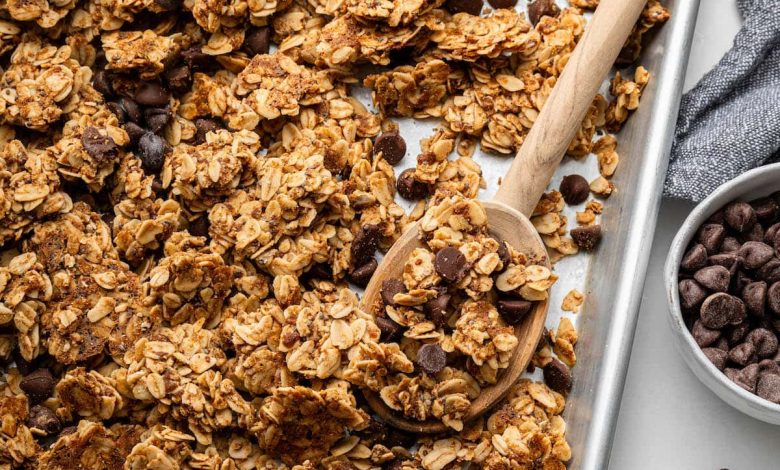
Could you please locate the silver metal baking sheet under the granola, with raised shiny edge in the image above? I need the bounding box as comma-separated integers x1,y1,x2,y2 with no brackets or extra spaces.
356,0,699,470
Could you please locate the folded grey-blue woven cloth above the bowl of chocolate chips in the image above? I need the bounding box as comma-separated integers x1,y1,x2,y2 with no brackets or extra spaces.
664,0,780,201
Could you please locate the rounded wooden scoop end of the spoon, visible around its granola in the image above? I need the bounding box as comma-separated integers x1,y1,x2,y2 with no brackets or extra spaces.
362,201,550,434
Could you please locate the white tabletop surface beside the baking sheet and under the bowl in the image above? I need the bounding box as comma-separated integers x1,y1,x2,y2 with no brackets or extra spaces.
610,0,780,470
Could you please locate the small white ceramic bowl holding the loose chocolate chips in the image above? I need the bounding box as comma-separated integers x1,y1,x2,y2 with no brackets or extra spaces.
664,163,780,424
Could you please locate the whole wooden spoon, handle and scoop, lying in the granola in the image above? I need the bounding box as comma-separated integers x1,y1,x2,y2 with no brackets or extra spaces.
362,0,646,433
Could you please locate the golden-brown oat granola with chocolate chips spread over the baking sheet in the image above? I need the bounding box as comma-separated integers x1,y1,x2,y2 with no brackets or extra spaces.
0,0,668,470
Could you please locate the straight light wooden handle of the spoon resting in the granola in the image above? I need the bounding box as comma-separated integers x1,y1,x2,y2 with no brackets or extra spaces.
494,0,646,217
